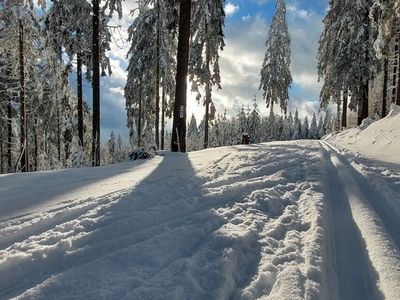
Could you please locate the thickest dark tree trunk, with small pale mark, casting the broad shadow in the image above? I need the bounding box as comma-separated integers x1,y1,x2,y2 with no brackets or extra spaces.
171,0,192,152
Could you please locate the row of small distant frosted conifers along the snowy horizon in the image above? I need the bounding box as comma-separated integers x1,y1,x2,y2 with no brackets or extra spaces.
187,101,337,151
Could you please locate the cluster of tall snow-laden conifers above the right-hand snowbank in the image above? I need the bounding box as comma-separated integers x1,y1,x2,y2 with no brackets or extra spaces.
318,0,400,127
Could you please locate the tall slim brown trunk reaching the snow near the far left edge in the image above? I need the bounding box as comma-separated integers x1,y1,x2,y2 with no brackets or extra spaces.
19,20,29,172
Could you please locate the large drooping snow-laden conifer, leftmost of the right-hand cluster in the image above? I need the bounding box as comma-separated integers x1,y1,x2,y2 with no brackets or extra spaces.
318,0,375,123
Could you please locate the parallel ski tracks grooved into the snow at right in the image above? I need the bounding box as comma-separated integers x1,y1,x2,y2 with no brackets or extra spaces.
321,142,400,300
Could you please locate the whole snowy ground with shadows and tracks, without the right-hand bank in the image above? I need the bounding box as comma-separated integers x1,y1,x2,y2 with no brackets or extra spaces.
0,111,400,300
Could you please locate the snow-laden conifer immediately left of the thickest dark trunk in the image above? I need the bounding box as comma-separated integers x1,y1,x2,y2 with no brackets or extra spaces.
125,0,176,147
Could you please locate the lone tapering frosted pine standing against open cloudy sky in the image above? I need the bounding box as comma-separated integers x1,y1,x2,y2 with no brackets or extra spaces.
259,0,292,114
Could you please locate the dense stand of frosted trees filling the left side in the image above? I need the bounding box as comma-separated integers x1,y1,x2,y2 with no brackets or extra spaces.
0,0,122,173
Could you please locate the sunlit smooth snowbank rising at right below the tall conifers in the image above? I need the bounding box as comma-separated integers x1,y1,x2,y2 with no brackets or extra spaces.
325,105,400,166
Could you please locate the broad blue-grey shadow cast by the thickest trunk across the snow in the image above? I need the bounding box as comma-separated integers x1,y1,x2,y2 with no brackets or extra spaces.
0,153,260,299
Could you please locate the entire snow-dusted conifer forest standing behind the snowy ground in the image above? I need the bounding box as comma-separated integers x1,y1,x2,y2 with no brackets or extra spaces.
0,0,400,173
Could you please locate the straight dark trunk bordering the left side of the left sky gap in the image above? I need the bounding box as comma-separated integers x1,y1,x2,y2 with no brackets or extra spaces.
92,0,100,166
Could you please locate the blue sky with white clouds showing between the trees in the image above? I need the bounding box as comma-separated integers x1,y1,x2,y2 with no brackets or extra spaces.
77,0,328,142
